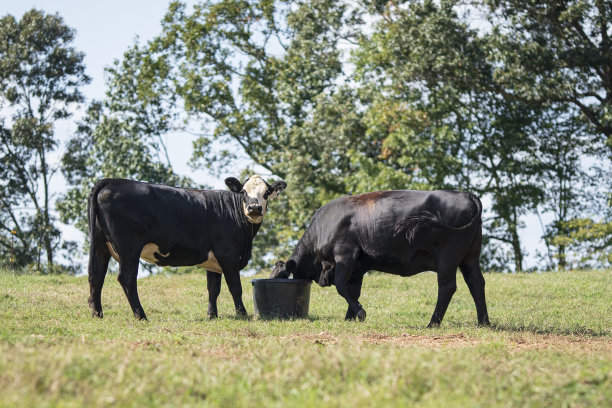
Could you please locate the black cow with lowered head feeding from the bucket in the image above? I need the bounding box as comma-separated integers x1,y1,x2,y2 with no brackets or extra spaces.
270,190,489,327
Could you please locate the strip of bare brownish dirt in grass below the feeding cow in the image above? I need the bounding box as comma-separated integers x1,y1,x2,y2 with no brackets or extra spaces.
290,332,612,353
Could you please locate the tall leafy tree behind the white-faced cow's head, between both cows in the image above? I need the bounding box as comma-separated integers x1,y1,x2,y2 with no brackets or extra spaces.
76,0,362,266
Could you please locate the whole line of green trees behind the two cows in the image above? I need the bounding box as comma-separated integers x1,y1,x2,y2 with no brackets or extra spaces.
0,0,612,271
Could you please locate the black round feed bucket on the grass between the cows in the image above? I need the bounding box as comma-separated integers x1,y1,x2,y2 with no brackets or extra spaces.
251,279,311,319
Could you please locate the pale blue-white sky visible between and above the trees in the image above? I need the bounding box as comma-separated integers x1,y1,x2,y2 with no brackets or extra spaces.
0,0,547,267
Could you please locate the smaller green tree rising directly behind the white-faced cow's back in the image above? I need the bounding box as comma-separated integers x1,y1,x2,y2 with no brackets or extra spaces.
57,34,196,242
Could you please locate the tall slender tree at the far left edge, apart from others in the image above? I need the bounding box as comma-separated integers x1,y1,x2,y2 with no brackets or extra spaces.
0,9,90,268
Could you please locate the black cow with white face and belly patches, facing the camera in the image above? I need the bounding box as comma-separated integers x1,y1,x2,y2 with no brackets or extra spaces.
87,175,287,319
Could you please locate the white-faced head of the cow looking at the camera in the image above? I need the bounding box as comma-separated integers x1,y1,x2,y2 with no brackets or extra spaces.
225,175,287,224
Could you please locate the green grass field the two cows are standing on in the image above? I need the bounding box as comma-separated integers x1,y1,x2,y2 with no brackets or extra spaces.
0,271,612,407
